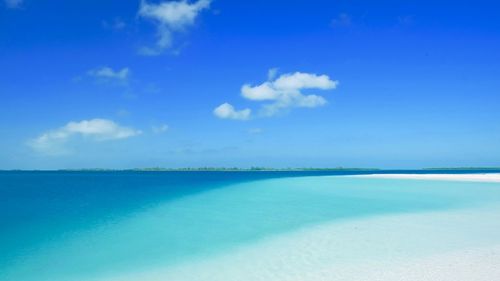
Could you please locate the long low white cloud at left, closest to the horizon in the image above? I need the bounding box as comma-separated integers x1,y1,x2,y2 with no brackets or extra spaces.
28,118,141,154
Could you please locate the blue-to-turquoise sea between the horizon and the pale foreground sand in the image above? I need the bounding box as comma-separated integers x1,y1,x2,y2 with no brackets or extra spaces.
0,172,500,281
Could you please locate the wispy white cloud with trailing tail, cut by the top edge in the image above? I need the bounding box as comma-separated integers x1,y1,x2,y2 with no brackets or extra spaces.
139,0,211,55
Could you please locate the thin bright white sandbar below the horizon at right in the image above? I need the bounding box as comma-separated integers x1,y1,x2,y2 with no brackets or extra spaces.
349,174,500,182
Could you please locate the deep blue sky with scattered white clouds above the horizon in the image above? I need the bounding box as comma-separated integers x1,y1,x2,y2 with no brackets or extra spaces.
0,0,500,169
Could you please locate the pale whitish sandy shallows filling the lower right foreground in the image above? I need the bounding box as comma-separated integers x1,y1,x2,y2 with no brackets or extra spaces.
92,203,500,281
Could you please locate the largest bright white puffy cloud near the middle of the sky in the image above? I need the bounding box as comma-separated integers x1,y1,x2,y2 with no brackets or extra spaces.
241,70,338,116
